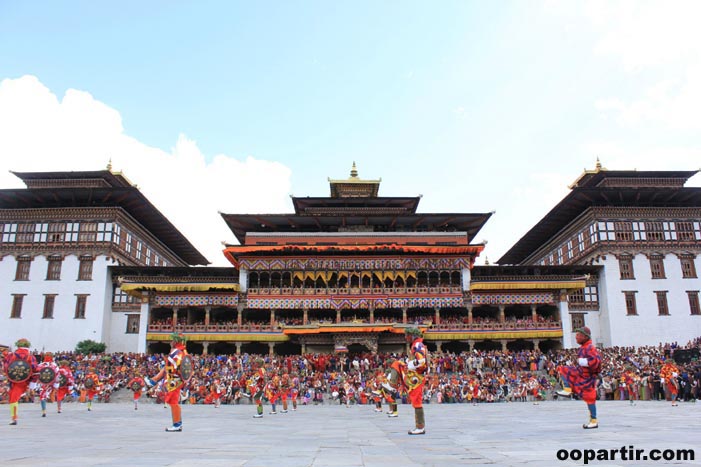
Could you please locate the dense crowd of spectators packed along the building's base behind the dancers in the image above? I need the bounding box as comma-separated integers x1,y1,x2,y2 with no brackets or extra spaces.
0,338,701,404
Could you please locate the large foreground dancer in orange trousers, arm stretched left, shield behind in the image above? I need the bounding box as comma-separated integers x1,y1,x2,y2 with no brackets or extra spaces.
144,333,194,432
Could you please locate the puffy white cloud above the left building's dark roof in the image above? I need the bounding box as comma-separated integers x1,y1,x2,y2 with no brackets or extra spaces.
0,76,291,266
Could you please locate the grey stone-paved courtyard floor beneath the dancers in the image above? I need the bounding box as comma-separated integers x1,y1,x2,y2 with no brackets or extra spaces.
0,401,701,467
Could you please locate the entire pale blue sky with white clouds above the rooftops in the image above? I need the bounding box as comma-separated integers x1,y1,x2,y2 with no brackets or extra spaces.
0,0,701,265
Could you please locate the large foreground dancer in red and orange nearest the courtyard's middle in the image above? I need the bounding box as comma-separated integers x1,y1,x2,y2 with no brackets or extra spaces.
383,327,428,435
